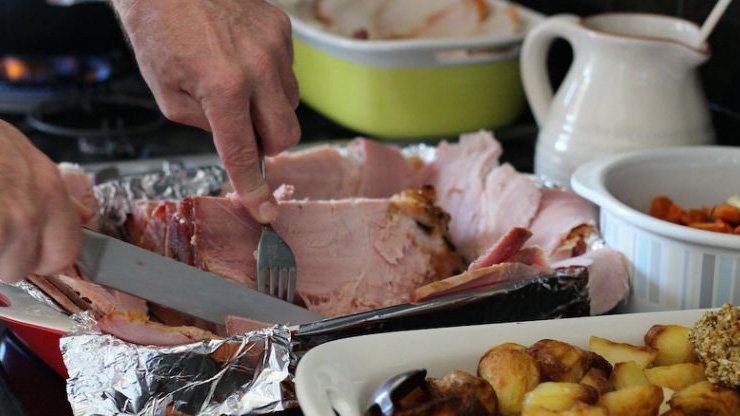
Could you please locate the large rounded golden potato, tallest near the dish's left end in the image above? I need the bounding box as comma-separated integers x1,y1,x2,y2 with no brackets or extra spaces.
478,344,540,416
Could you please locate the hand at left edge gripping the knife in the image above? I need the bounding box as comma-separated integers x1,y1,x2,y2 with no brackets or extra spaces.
0,121,84,282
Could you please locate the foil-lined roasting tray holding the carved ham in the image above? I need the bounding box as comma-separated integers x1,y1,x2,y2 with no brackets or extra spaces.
44,151,590,416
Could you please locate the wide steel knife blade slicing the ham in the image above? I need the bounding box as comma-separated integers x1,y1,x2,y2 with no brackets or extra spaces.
77,229,324,325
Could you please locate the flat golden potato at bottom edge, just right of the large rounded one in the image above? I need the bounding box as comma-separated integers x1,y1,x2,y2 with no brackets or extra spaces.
522,381,599,410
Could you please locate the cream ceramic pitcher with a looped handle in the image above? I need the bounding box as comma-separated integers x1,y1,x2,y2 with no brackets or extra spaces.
521,13,714,185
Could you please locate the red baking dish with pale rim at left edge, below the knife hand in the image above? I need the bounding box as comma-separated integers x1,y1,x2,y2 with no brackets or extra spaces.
0,284,74,378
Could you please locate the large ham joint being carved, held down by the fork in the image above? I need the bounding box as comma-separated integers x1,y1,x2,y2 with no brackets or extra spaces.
188,197,453,316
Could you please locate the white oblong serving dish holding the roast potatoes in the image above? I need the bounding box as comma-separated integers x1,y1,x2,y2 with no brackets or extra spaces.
295,310,704,416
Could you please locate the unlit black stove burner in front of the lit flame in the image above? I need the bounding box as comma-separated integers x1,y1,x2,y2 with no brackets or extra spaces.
26,96,165,158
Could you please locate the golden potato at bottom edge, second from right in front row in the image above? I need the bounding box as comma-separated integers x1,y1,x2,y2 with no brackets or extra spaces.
598,385,663,416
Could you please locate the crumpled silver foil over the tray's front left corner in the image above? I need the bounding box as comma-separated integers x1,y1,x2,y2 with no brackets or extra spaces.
60,324,297,416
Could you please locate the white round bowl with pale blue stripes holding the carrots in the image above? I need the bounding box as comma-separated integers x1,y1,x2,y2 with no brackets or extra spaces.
571,146,740,312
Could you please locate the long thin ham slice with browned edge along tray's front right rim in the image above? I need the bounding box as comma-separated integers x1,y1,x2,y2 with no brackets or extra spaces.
411,262,542,302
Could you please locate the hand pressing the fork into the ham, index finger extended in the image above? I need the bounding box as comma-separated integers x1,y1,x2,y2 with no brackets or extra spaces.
113,0,300,223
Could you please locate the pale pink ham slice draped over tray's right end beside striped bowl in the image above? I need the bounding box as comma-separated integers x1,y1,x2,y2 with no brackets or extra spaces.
553,248,629,315
